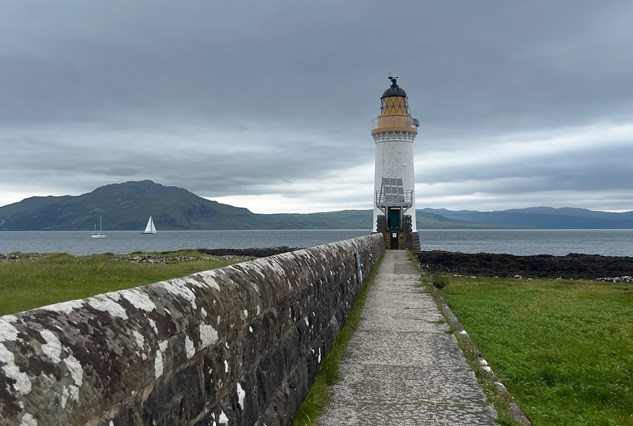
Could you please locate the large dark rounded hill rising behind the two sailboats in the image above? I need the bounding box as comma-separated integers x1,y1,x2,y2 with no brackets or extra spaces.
0,180,255,231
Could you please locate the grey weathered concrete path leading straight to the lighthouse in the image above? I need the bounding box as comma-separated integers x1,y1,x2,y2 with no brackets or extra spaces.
318,250,496,426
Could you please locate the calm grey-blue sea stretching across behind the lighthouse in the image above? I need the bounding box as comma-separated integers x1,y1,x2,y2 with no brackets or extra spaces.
0,229,633,256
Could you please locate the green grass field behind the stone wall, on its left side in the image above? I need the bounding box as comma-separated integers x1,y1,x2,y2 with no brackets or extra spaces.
0,250,246,315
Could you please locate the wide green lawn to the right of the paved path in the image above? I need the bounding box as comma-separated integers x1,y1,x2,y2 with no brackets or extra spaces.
441,277,633,426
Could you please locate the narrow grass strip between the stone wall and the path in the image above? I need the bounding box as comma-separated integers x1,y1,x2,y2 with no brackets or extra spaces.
293,255,382,426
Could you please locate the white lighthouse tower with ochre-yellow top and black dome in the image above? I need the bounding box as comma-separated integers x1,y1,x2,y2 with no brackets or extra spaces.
371,77,420,253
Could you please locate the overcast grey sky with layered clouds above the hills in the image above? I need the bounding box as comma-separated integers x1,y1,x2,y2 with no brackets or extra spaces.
0,0,633,213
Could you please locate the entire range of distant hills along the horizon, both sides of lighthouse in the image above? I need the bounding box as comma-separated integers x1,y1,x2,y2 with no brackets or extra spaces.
0,180,633,231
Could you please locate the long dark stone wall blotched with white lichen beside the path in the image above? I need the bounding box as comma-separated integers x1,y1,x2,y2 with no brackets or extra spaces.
0,234,384,426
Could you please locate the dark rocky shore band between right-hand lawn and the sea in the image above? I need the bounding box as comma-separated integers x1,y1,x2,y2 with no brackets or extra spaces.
417,250,633,282
